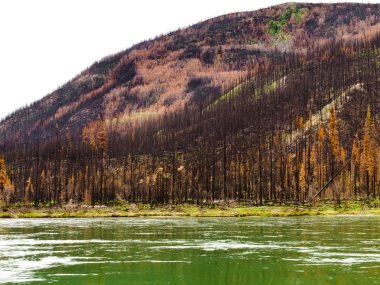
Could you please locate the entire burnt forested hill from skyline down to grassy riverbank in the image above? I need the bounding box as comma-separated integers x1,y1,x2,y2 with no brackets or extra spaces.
0,4,380,207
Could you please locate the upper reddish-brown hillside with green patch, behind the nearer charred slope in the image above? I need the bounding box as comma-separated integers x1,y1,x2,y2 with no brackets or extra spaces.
0,3,380,144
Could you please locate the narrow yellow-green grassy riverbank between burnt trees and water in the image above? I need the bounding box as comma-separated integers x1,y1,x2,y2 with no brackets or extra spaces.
0,203,380,218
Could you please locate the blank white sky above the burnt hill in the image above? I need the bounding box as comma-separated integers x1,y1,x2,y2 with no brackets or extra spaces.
0,0,380,118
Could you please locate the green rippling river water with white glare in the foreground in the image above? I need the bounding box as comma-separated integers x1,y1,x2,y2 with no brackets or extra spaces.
0,217,380,285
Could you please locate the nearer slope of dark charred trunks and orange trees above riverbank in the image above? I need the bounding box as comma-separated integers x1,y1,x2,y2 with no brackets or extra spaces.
0,33,380,207
